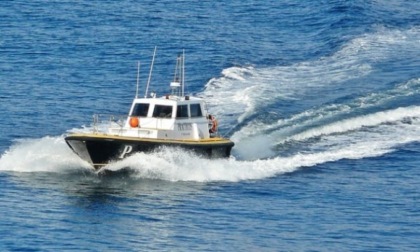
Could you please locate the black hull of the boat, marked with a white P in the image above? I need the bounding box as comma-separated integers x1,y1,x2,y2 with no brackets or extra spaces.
65,135,234,169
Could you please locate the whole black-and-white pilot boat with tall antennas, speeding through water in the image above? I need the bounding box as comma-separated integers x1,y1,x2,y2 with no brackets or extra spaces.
65,48,234,170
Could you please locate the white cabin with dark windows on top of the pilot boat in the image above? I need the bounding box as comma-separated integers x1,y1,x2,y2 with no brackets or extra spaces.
109,95,213,140
